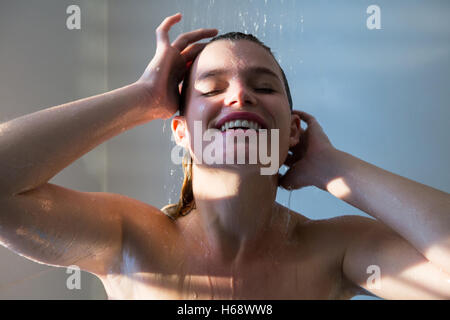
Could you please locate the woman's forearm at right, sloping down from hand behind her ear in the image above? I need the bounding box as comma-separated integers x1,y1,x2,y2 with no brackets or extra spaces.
317,149,450,272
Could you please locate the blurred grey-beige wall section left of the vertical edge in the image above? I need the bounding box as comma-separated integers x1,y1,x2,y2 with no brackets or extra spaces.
0,0,108,299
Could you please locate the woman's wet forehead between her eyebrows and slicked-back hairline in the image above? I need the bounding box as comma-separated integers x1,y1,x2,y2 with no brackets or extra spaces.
191,40,282,81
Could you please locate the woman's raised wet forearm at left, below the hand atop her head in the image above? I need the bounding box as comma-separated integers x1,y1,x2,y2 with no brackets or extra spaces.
0,84,155,195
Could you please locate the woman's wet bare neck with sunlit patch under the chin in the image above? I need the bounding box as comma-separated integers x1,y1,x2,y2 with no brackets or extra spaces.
192,164,278,261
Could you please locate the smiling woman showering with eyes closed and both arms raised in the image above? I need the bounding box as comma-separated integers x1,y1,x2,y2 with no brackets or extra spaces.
0,14,450,299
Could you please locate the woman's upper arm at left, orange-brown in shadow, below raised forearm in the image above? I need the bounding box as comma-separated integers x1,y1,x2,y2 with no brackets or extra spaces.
0,183,125,274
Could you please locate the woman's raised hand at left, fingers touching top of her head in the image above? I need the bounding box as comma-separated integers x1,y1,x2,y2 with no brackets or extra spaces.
137,13,218,119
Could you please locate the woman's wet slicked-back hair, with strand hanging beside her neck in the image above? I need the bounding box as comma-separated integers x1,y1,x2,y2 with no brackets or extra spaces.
161,32,292,220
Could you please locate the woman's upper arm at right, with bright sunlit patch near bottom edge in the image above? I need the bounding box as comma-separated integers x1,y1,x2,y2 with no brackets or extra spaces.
342,216,450,299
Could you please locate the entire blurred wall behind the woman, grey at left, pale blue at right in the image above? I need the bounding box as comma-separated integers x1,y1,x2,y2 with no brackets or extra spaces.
0,0,450,299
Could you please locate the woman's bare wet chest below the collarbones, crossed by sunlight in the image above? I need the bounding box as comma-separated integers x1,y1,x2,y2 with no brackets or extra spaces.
102,252,340,300
